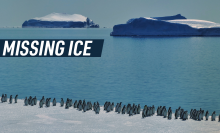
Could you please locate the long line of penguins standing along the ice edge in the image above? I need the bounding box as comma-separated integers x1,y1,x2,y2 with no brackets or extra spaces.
1,94,220,122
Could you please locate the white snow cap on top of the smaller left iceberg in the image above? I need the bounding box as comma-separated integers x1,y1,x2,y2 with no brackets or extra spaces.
33,13,87,22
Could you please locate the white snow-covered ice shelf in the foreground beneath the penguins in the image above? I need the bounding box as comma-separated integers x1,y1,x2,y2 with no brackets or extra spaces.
0,100,220,133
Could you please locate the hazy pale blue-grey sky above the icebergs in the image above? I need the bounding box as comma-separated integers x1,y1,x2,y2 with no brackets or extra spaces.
0,0,220,27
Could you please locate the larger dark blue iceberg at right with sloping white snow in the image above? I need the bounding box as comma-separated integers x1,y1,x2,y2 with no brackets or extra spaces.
110,14,220,36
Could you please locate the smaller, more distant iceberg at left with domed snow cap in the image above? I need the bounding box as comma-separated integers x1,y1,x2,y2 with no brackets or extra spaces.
22,13,99,28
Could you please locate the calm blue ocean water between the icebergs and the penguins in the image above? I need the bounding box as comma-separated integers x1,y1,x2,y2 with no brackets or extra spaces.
0,29,220,114
